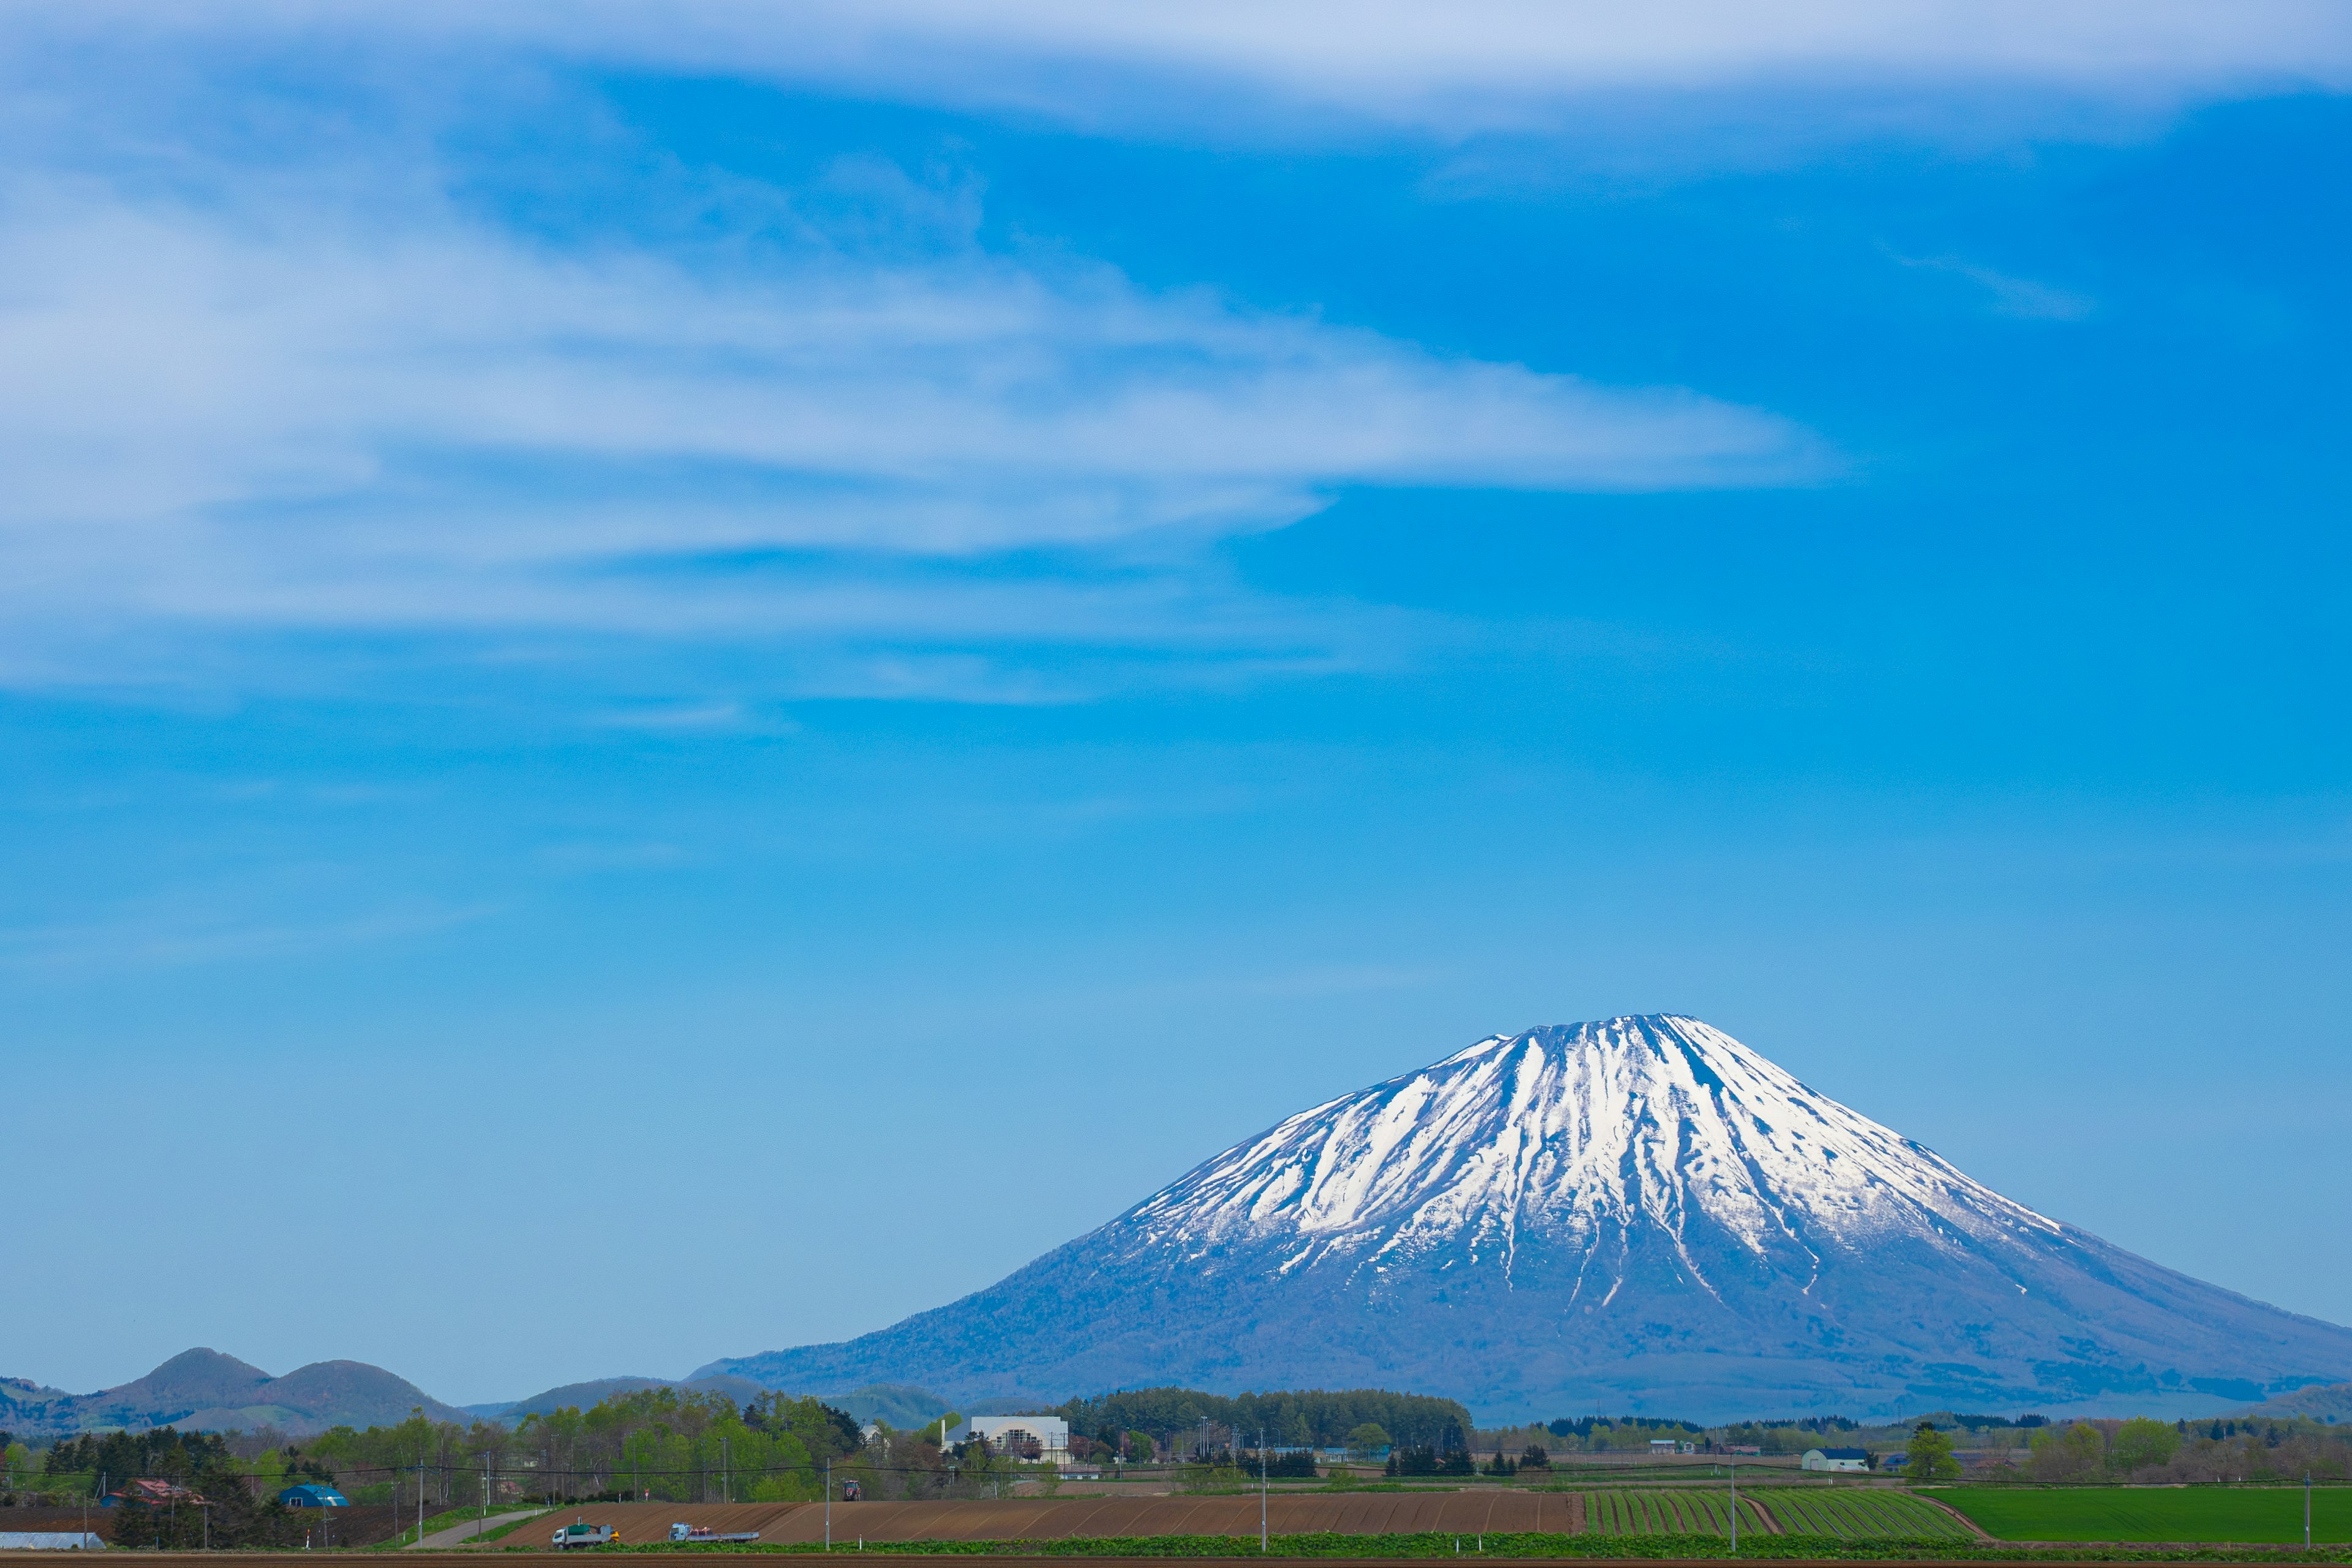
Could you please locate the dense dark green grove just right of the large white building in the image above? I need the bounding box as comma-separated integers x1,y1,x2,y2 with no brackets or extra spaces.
1054,1387,1470,1453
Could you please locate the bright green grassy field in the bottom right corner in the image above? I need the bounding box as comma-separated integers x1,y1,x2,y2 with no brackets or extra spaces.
1936,1486,2352,1547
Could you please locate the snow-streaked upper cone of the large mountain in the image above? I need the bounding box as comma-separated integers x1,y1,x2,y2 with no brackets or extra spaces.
1129,1018,2060,1300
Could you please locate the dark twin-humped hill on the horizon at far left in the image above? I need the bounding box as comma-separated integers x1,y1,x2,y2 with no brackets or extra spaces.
0,1349,468,1436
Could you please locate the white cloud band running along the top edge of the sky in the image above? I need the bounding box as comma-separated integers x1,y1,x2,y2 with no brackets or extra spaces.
23,0,2352,132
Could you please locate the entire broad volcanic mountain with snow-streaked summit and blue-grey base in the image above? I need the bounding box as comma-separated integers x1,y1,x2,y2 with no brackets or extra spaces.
696,1016,2352,1417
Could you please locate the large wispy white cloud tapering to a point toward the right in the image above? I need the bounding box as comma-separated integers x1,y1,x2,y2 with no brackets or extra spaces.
0,157,1834,701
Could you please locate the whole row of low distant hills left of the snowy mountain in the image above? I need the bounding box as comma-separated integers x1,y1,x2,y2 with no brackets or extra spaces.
0,1349,948,1439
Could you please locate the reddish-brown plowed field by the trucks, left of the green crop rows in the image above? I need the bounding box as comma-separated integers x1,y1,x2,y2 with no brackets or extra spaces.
489,1490,1583,1549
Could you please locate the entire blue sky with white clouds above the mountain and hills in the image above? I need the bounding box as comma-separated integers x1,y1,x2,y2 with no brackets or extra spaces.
0,0,2352,1401
